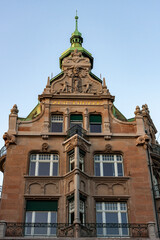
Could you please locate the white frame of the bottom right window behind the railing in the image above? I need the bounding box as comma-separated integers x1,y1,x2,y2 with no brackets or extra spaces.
96,202,129,237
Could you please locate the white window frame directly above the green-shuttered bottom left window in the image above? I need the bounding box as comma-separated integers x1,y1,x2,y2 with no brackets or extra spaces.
30,153,59,176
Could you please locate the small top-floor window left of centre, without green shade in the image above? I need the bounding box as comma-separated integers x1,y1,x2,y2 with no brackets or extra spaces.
51,114,63,132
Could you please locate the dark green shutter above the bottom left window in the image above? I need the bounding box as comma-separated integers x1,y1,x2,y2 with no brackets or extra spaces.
26,201,58,211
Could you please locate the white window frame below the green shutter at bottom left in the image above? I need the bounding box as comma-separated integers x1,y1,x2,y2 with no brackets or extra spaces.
25,211,57,236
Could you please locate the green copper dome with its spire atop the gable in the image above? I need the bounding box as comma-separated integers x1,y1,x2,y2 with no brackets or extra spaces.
59,14,93,69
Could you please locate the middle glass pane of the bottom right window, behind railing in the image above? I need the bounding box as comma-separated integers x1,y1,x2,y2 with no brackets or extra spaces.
106,212,119,235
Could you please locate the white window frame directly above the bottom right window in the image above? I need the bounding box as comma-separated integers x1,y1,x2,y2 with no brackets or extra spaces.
94,154,124,177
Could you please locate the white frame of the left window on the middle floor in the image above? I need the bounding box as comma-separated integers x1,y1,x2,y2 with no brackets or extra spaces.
29,153,59,177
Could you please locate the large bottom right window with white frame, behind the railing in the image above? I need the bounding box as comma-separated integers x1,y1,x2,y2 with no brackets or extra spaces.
96,202,128,237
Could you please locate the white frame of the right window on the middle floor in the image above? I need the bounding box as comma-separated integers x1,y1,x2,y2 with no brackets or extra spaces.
94,154,124,177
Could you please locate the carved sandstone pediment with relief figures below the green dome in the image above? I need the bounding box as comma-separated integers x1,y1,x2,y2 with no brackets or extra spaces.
51,49,109,95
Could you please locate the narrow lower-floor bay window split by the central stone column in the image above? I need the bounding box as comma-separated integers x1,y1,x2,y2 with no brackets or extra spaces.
69,199,85,224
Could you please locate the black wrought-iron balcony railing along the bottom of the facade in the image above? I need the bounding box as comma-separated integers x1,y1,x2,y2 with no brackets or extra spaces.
5,223,148,238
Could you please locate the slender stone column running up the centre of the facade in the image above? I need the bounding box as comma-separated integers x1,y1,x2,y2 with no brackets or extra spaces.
74,146,80,238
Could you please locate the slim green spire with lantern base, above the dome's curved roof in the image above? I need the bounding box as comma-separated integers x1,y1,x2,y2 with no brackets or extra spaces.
70,10,83,47
